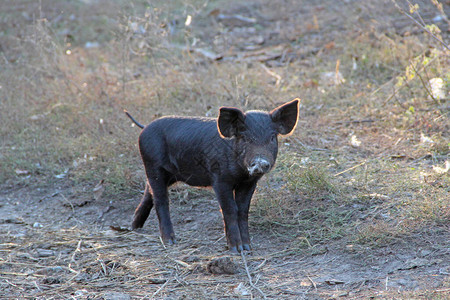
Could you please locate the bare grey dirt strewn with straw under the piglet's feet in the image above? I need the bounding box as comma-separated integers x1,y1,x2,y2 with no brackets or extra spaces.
0,176,450,299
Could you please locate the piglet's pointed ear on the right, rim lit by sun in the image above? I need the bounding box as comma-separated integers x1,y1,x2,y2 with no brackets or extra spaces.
270,98,300,135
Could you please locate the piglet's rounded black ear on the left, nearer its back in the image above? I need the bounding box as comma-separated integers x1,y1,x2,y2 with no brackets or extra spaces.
217,107,245,138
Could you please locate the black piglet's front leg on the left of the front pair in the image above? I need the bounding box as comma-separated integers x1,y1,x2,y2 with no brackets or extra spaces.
213,183,243,253
